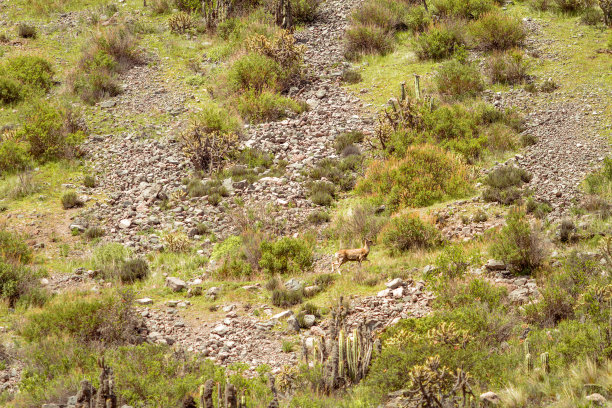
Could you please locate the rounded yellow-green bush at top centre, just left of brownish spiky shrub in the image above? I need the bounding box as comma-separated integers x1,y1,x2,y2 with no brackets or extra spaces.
228,53,283,93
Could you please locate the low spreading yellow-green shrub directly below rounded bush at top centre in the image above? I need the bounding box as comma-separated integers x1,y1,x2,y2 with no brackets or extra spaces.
237,89,305,123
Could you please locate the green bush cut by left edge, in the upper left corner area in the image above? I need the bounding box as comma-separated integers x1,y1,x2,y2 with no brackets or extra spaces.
4,55,53,92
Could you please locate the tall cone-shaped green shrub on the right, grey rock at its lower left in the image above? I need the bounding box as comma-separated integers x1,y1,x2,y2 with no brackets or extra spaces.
491,209,547,274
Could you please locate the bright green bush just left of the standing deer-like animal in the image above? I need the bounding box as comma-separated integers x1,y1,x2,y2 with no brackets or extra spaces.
259,237,313,275
